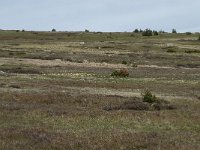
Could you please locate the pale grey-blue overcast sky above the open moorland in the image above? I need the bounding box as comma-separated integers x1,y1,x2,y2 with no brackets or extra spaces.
0,0,200,32
